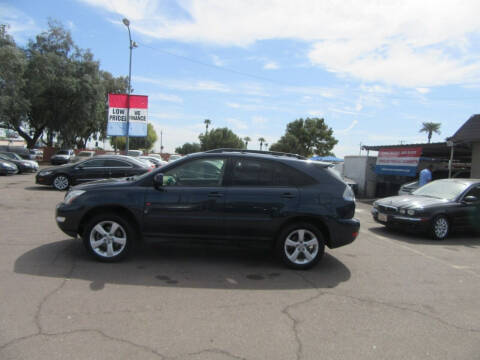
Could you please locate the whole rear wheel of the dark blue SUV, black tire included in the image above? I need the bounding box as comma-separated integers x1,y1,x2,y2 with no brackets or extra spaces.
276,223,325,270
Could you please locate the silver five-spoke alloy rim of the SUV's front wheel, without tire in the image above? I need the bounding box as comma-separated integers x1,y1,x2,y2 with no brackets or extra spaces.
90,221,127,258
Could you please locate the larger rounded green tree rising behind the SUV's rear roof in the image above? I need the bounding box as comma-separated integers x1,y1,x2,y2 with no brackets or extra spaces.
270,118,338,156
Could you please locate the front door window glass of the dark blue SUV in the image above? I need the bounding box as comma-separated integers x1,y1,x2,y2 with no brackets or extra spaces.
163,158,226,186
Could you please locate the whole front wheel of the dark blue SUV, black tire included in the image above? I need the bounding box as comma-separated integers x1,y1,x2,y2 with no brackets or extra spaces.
83,213,135,262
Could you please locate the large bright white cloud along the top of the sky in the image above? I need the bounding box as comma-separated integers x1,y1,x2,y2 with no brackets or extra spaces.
82,0,480,88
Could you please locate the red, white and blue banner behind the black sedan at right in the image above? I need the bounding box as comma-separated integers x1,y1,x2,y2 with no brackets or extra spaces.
375,147,422,176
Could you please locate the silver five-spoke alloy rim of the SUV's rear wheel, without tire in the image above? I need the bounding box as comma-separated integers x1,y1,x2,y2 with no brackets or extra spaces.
284,229,319,265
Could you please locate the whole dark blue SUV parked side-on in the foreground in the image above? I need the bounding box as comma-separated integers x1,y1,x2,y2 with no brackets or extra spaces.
56,149,360,269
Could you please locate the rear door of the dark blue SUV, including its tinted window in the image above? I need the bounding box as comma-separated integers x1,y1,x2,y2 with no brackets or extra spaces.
225,158,299,241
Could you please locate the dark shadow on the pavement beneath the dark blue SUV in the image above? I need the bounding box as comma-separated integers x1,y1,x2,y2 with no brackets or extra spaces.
14,239,350,291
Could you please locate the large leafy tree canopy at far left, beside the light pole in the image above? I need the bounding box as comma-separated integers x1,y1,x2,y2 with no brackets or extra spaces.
0,20,127,148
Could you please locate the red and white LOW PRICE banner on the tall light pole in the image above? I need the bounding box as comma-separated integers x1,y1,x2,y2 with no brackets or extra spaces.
107,94,148,136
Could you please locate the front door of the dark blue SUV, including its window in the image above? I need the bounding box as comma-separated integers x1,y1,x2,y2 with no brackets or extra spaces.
144,157,227,239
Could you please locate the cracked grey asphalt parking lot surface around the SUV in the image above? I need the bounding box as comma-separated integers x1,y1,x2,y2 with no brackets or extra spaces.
0,175,480,360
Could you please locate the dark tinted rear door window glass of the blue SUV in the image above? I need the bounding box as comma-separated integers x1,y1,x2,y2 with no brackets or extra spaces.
232,159,275,186
